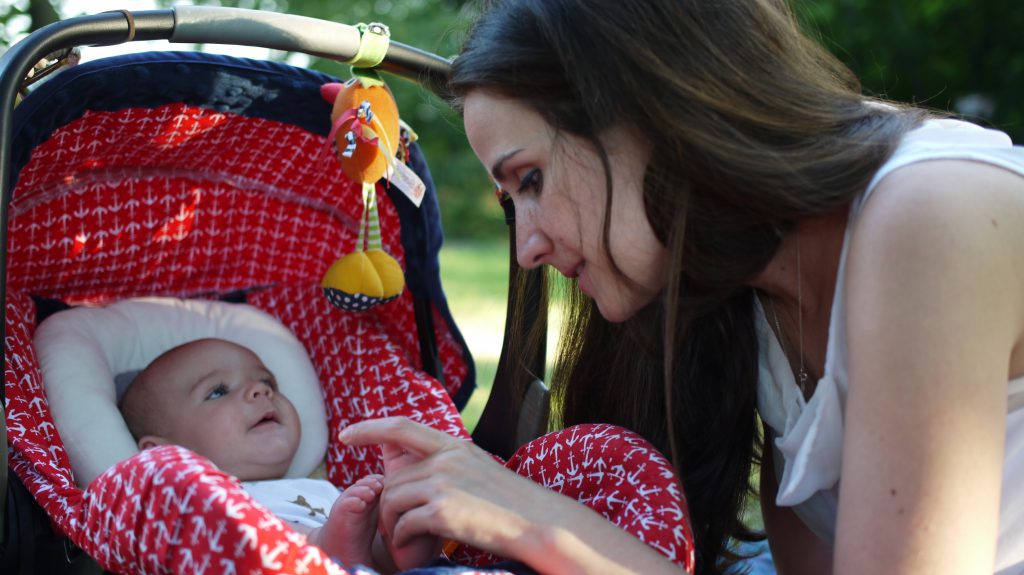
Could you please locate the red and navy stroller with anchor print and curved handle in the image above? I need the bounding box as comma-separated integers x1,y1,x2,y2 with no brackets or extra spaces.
0,7,693,573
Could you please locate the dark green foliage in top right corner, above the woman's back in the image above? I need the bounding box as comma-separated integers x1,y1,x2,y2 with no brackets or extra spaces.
795,0,1024,143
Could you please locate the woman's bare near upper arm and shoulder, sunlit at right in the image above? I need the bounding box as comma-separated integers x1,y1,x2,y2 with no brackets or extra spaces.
835,157,1024,574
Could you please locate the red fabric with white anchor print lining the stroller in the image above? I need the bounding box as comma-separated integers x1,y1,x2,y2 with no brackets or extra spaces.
4,104,693,575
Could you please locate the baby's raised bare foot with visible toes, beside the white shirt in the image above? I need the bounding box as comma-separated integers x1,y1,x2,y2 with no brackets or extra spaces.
312,475,384,566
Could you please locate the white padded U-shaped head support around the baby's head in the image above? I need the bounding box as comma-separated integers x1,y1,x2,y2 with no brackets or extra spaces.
35,298,327,487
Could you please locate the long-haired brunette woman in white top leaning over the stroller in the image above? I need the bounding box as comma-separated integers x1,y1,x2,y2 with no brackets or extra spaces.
343,0,1024,574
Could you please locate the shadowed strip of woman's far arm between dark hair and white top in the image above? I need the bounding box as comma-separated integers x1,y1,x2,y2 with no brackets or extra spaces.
760,433,833,575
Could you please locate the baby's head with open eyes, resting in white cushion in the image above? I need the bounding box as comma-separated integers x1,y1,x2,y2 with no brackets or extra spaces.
121,339,300,480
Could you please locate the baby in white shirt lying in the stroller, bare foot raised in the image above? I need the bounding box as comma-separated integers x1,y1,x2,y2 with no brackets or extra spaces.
121,339,437,572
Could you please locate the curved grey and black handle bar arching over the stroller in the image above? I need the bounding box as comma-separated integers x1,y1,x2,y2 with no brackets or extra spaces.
0,6,451,405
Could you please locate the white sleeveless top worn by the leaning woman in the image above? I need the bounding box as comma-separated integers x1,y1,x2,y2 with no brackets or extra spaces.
755,120,1024,575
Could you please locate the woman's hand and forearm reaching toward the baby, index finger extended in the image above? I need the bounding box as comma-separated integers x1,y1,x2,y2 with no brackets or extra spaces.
341,417,682,574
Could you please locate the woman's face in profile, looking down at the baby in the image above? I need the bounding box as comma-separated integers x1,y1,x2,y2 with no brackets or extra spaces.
464,91,668,321
